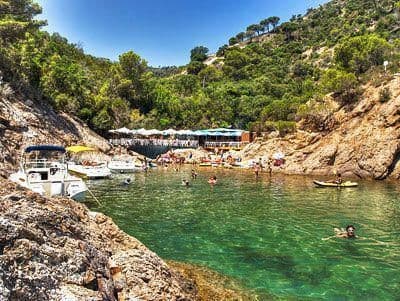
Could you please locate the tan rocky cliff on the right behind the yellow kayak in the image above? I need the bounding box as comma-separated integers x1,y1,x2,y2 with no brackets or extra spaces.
242,77,400,180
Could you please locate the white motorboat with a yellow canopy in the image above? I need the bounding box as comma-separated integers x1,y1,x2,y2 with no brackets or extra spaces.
67,145,111,179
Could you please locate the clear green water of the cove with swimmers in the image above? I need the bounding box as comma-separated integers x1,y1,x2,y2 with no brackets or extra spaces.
89,169,400,300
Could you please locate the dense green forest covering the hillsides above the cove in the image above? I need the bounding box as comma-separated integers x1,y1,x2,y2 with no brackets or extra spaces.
0,0,400,133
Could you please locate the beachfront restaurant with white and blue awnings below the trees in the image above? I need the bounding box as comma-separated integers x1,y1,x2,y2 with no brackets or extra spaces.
109,128,251,157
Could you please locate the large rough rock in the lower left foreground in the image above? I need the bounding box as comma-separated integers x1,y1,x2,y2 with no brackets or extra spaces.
0,180,197,301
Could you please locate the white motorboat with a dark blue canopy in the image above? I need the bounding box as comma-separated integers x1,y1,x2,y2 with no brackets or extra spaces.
10,145,88,201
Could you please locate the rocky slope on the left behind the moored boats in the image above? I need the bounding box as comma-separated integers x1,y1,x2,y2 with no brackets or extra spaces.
0,83,109,173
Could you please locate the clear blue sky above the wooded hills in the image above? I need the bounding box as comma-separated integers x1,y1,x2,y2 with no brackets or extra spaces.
37,0,327,66
